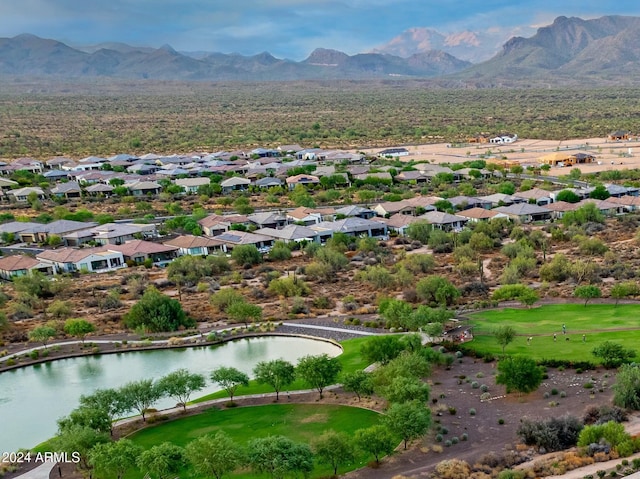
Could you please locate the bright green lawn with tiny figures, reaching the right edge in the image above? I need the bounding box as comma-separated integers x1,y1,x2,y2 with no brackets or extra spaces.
467,304,640,362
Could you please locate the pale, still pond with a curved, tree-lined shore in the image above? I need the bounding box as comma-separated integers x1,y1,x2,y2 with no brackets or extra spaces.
0,336,341,453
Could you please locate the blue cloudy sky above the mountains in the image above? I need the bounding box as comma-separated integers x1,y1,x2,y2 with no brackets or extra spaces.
0,0,640,60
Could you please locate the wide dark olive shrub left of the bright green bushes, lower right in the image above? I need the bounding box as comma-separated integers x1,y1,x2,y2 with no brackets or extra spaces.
517,416,583,452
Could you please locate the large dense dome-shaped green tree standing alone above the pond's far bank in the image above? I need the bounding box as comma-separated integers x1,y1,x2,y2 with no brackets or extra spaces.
124,286,194,332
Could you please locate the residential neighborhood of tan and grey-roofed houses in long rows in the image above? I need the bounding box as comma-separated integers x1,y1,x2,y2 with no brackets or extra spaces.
0,141,640,279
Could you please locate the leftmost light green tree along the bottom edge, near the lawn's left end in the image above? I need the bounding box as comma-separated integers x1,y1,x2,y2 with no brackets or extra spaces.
88,438,142,479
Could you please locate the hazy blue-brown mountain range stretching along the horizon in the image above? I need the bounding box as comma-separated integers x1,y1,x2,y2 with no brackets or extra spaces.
0,16,640,87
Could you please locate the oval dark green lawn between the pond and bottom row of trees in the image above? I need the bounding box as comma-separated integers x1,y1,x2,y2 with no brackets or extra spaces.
128,404,380,478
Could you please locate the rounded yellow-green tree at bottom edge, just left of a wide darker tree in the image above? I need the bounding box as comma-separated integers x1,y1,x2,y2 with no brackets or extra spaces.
185,431,245,479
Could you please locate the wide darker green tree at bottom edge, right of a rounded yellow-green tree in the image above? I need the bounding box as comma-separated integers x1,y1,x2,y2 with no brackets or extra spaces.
247,436,313,479
